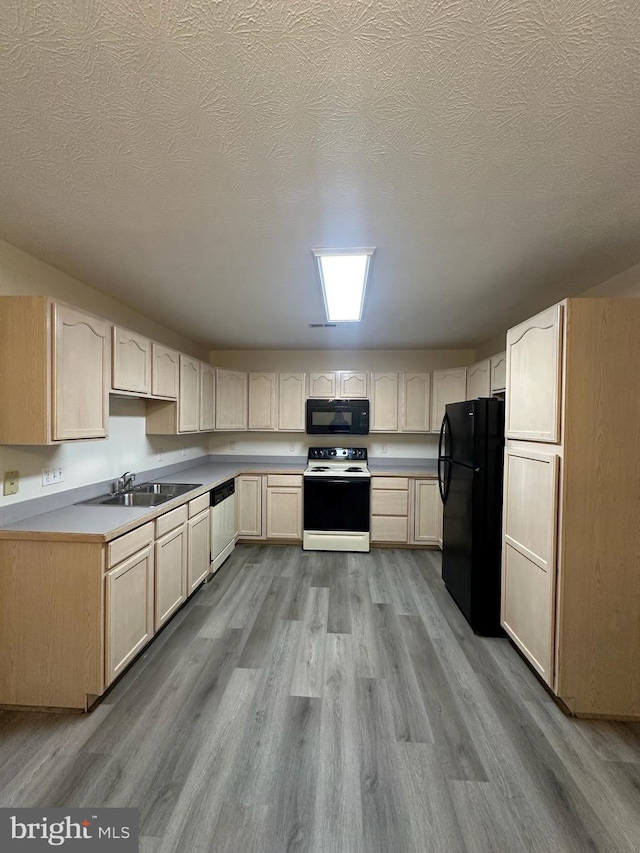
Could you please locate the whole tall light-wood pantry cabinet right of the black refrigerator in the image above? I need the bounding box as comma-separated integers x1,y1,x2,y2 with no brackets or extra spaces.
502,299,640,719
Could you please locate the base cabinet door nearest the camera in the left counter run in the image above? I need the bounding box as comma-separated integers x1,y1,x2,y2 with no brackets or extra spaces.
105,545,154,684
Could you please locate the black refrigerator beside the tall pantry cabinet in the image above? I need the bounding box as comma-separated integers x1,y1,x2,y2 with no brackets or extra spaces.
438,397,504,636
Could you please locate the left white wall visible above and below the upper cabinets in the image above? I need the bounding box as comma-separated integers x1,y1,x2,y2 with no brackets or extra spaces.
0,241,209,506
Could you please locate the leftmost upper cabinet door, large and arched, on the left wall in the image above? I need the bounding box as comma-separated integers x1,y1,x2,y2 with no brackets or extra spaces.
52,305,111,441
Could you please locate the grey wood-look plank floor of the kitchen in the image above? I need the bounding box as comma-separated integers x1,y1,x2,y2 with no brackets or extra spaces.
0,546,640,853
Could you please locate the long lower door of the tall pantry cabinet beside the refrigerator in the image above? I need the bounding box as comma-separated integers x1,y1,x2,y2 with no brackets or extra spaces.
502,447,558,685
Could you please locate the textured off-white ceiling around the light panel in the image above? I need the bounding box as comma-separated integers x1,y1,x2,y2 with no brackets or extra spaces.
0,0,640,349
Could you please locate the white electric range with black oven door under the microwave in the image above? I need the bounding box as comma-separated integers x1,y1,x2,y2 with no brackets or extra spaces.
302,447,371,551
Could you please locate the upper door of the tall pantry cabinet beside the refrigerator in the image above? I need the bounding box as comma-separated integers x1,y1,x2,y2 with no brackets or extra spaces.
505,305,562,442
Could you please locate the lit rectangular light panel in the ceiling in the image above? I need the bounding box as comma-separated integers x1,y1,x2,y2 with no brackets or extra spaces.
312,246,375,323
